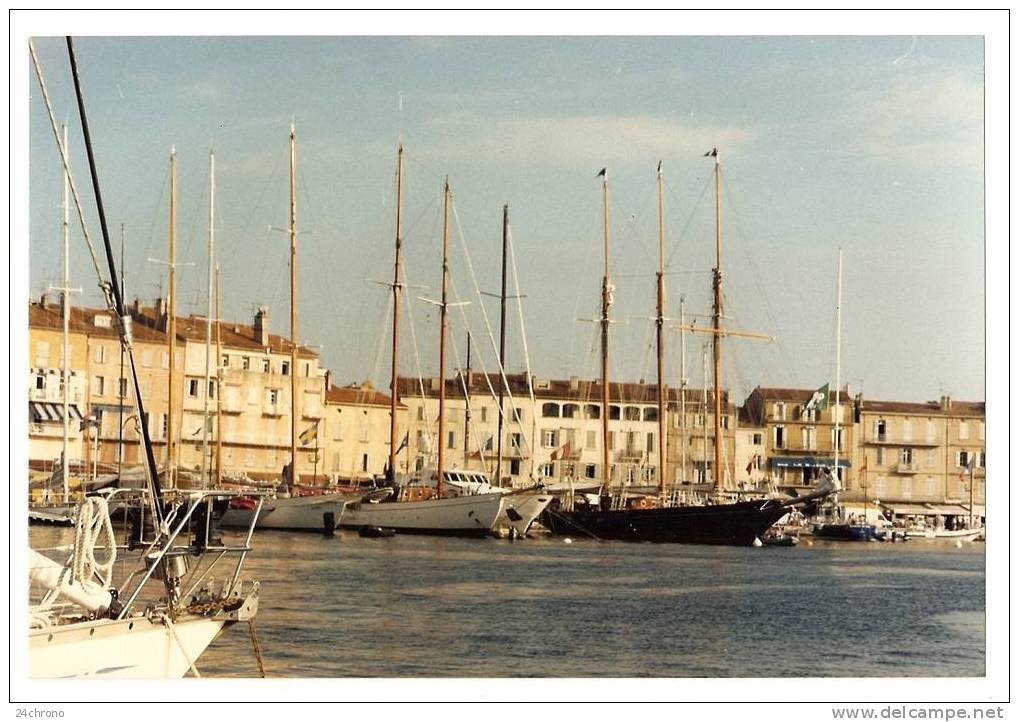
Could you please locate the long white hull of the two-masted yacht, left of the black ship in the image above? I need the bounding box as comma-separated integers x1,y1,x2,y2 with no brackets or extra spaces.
339,492,503,537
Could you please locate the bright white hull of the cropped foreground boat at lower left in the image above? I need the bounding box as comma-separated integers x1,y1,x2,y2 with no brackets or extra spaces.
29,615,232,679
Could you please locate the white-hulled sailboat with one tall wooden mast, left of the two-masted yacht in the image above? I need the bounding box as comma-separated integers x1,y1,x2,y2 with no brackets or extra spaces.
213,123,351,533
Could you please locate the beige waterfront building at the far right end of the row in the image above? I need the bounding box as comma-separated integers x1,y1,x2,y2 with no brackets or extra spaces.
854,396,986,516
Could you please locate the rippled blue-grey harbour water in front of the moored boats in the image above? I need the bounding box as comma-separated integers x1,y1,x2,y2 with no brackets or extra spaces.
34,532,984,677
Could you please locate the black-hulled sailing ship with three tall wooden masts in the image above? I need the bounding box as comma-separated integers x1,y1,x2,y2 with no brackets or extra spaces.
541,154,832,545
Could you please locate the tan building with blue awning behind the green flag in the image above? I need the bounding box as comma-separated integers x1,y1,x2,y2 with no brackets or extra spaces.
744,386,859,493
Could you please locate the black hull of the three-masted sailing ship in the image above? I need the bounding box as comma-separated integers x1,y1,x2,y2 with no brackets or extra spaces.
540,499,789,546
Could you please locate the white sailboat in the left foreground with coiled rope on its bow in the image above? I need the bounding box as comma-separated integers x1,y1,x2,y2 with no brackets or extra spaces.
28,38,259,678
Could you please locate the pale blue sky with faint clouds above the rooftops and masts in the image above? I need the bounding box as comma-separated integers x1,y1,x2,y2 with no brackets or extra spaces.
24,23,985,401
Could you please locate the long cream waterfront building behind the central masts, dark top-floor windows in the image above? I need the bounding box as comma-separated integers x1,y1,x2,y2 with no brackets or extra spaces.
398,372,658,487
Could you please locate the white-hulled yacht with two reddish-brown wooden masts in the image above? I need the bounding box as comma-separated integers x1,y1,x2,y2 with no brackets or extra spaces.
340,161,505,537
